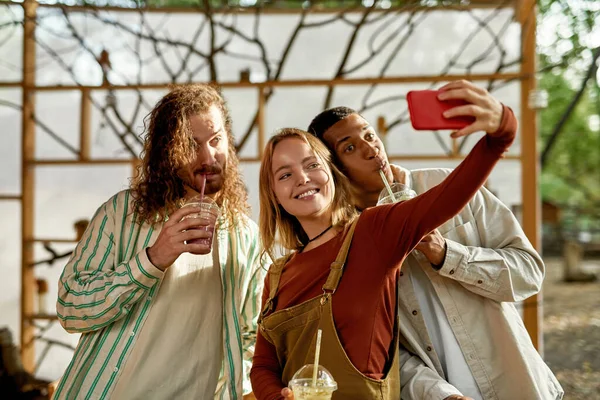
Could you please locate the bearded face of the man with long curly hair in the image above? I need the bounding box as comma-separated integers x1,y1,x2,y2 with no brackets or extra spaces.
179,105,229,195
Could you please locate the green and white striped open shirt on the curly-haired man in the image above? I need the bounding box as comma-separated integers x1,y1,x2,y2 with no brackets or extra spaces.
54,190,269,400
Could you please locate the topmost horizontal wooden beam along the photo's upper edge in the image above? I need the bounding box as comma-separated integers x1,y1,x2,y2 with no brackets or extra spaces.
40,0,515,15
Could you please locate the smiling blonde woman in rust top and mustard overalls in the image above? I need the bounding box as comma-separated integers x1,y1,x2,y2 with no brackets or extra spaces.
251,107,517,400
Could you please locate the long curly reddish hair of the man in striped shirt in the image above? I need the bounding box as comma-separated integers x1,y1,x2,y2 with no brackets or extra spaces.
131,84,250,228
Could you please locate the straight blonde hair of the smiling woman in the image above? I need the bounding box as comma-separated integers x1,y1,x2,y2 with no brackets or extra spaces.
259,128,357,258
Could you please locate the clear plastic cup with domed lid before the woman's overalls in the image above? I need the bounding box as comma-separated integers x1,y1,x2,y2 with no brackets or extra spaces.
288,364,337,400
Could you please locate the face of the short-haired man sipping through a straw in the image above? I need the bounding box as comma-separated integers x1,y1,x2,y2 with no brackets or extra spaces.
323,114,393,192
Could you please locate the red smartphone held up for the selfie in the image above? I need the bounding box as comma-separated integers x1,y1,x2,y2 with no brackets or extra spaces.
406,90,475,131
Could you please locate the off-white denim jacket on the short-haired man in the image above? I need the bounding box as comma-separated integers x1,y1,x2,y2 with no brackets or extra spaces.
394,167,563,400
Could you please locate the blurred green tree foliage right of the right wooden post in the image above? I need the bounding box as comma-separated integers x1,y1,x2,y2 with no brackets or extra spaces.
538,0,600,215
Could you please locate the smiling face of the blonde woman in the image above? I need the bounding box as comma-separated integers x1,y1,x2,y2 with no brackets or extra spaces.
271,138,335,222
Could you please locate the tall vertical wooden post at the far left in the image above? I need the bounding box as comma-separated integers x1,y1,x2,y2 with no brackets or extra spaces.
21,0,38,372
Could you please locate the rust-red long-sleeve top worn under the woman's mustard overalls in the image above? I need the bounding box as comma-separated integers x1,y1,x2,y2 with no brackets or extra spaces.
250,106,517,400
